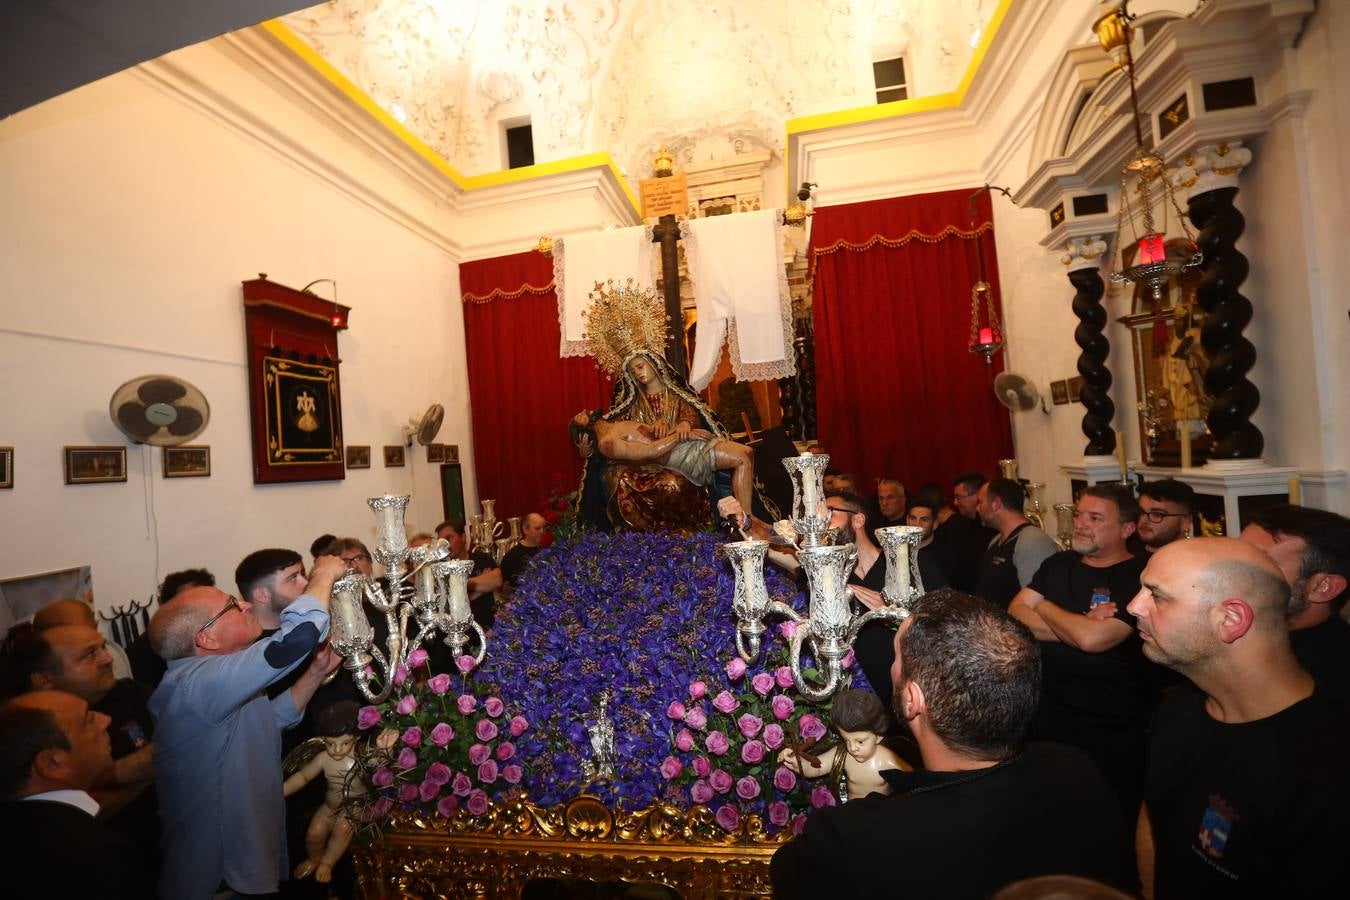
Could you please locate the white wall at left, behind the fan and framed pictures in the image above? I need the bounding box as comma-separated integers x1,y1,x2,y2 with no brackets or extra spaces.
0,38,474,607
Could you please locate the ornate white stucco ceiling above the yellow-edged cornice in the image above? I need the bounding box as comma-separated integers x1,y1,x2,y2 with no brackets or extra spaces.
284,0,995,179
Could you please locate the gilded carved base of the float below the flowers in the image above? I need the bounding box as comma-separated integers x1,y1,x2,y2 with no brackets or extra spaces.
352,795,784,900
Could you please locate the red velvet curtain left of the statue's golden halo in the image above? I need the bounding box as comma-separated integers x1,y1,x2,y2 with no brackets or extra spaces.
459,251,610,519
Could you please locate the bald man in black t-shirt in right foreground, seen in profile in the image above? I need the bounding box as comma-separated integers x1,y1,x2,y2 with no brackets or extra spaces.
1129,538,1350,900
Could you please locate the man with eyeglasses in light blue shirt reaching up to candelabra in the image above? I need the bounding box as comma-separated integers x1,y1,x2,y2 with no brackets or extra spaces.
150,556,347,900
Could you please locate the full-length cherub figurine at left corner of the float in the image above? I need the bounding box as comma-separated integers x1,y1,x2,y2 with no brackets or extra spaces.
282,700,366,884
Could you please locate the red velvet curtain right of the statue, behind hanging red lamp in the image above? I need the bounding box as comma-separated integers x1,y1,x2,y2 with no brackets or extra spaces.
811,189,1013,493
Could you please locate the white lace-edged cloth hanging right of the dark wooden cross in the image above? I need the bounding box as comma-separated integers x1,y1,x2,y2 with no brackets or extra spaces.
680,209,797,390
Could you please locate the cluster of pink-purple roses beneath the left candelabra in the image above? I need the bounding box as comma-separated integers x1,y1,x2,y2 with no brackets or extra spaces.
356,649,529,818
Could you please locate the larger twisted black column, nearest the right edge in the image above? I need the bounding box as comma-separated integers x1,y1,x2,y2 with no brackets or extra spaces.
1187,188,1265,459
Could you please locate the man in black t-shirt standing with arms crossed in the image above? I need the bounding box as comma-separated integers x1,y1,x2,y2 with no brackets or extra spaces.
1008,484,1149,822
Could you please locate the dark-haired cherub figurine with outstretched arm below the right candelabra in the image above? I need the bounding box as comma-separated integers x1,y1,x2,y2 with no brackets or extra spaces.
778,690,909,800
